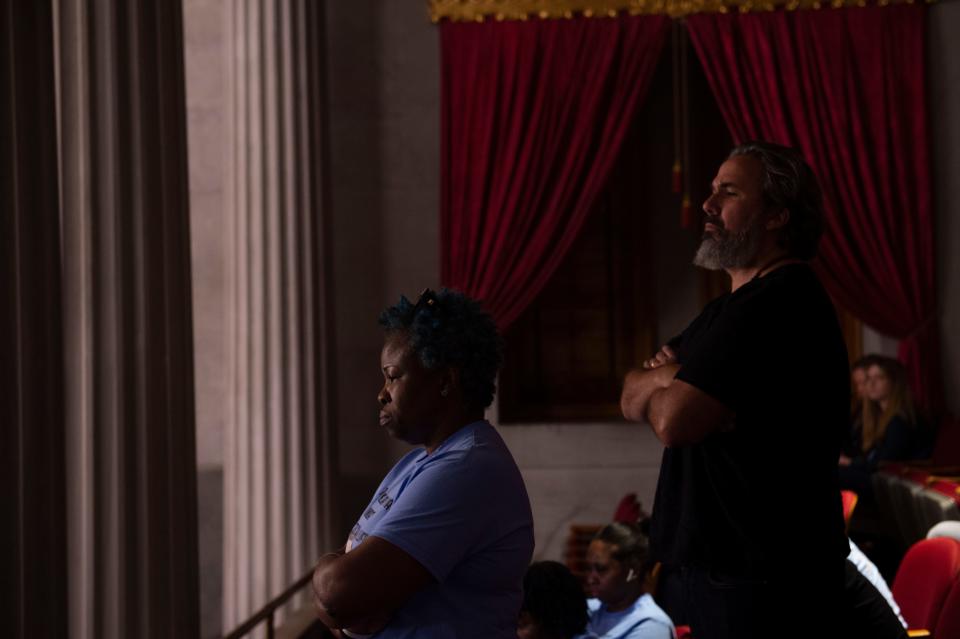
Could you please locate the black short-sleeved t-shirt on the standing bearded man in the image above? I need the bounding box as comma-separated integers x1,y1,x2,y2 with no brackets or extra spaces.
650,264,850,575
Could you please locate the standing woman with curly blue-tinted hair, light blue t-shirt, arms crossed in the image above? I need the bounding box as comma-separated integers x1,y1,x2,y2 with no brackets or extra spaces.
313,290,533,639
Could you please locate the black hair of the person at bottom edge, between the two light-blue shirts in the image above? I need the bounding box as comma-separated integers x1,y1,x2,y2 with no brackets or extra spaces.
520,561,589,637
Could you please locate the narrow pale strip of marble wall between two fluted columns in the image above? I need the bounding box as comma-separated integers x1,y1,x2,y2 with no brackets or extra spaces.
183,0,228,638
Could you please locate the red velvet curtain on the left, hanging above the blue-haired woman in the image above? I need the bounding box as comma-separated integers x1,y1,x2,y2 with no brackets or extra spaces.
440,16,669,329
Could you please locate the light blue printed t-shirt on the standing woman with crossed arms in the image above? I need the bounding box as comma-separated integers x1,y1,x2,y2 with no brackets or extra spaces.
348,421,533,639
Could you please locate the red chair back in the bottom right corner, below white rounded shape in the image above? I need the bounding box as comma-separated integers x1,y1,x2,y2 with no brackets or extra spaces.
892,537,960,636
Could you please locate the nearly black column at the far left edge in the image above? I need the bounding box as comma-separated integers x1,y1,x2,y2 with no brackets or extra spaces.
0,0,67,639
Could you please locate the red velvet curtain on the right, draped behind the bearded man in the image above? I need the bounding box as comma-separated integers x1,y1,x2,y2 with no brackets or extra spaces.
687,5,943,413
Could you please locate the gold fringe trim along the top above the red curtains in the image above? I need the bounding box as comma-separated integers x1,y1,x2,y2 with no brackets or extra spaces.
428,0,935,23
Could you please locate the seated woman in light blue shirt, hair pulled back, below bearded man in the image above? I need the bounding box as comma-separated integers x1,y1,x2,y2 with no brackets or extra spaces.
583,522,675,639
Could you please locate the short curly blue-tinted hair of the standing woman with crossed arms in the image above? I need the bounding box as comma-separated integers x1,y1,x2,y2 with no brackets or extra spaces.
380,288,503,409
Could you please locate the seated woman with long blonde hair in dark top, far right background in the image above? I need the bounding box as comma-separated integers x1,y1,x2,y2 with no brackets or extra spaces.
840,355,920,497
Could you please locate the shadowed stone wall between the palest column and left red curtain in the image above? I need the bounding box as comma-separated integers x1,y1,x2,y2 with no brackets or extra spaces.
327,0,440,534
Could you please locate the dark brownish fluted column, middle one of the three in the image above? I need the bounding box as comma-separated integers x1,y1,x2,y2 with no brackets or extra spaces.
54,0,200,639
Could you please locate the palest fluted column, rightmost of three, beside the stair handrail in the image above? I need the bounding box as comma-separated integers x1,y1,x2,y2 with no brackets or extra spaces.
223,0,334,629
